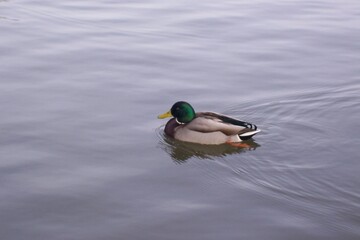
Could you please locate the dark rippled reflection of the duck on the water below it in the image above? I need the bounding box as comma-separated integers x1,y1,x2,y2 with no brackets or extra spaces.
159,134,260,163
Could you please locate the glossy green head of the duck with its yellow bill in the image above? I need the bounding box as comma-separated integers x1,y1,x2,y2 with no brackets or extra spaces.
158,101,195,123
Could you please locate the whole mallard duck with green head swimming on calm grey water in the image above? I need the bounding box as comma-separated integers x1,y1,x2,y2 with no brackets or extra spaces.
158,101,260,146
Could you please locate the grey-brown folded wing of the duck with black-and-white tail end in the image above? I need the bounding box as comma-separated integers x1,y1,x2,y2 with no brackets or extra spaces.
186,112,257,136
